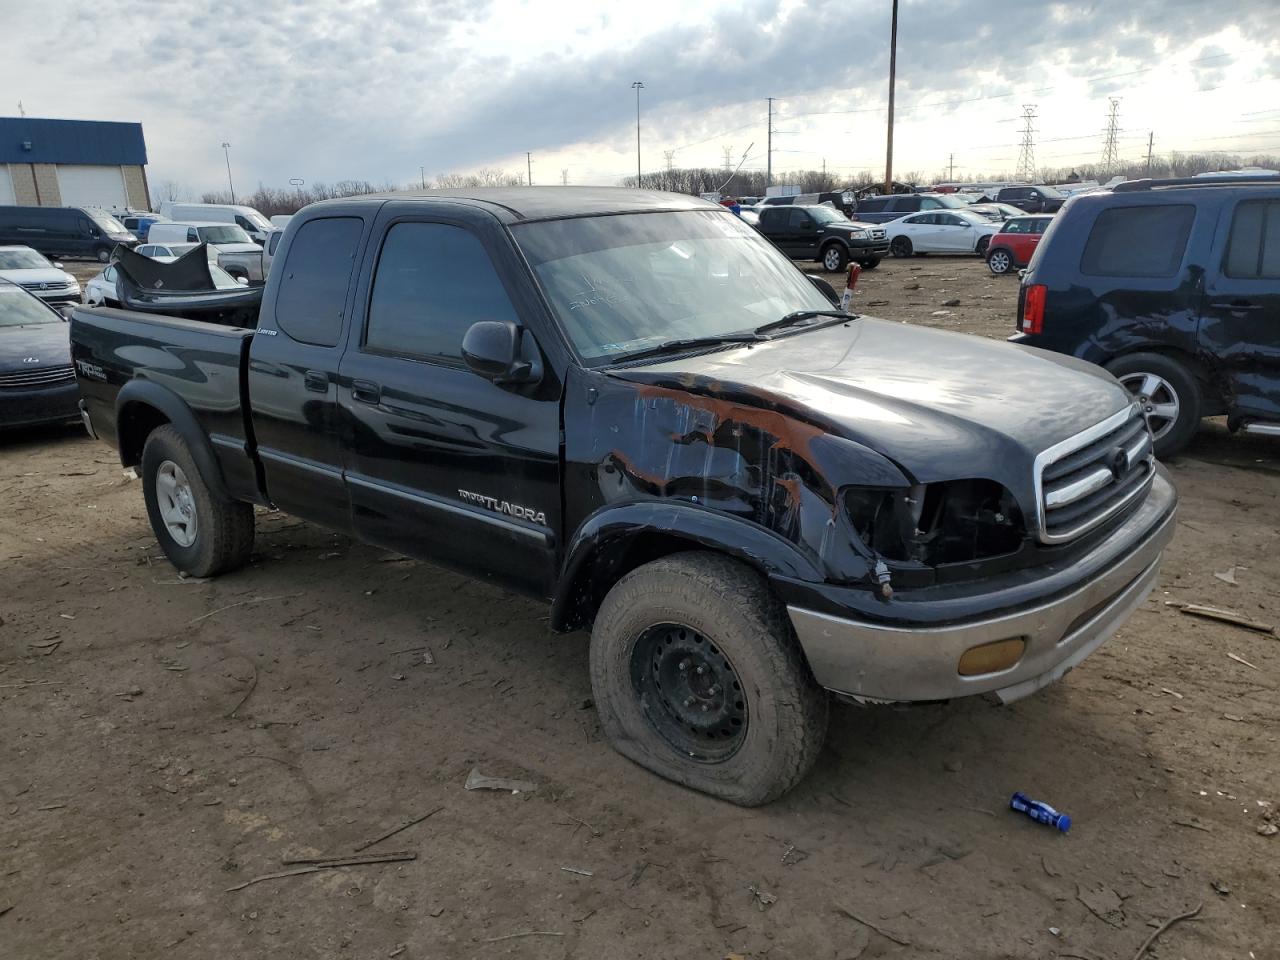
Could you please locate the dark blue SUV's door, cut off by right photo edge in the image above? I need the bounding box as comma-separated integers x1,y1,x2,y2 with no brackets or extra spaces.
1199,198,1280,421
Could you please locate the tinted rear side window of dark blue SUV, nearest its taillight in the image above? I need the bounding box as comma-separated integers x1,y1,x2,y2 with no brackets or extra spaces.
1080,204,1196,278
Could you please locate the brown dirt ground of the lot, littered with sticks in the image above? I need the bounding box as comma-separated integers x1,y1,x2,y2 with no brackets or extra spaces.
0,257,1280,960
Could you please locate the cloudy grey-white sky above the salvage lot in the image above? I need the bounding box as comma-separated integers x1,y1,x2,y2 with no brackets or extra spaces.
0,0,1280,193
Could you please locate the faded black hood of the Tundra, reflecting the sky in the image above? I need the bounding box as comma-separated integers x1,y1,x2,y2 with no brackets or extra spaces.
611,319,1132,494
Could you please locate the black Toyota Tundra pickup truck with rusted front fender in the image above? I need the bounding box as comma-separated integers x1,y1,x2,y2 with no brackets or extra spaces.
72,187,1175,805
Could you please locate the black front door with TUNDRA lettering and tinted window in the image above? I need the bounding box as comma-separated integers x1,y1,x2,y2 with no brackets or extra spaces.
340,204,561,596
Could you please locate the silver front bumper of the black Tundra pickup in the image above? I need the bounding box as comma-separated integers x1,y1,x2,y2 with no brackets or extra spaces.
787,480,1175,703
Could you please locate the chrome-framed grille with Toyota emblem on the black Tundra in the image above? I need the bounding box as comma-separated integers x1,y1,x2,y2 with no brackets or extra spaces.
1036,404,1156,543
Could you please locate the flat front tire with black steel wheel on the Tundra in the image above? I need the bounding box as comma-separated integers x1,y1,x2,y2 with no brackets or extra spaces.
590,552,828,806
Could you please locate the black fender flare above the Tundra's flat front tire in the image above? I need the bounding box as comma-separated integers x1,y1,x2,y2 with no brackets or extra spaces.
552,500,824,631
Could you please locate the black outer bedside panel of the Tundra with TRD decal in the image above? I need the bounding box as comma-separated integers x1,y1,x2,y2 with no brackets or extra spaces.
72,307,257,499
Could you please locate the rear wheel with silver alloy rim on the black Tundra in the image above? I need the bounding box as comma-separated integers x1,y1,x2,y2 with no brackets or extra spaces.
141,424,253,577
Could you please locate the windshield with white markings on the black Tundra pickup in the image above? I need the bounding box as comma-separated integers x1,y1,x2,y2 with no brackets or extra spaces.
512,210,832,366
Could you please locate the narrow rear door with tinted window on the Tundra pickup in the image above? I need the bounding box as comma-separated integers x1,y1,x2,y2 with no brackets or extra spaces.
248,215,366,531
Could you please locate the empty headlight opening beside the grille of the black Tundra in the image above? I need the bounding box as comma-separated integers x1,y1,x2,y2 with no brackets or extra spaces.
845,479,1025,566
